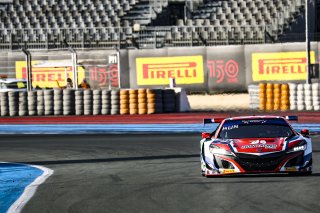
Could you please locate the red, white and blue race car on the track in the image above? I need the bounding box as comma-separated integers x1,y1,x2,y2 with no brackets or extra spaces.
200,116,312,177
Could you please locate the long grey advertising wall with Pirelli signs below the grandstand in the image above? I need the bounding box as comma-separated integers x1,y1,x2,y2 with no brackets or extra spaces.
0,42,320,93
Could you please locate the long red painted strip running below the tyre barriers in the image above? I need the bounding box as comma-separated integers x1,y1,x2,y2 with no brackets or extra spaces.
0,112,320,124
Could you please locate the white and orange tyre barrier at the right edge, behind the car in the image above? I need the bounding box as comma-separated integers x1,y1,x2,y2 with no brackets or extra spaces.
248,83,320,111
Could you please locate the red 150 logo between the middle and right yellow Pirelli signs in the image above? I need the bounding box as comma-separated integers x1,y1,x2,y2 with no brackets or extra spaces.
207,59,239,84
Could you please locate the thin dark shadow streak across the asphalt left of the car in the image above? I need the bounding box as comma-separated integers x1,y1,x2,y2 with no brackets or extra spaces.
17,154,199,165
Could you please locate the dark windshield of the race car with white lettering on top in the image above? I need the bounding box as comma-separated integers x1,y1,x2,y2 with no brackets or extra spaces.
218,118,294,139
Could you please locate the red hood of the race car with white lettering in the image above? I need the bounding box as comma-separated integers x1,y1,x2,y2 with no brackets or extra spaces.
230,138,285,154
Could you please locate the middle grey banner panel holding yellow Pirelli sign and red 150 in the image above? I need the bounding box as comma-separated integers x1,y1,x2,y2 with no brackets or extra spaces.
129,46,246,91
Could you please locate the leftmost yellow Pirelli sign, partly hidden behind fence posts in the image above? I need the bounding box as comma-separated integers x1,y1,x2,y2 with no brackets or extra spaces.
16,61,84,88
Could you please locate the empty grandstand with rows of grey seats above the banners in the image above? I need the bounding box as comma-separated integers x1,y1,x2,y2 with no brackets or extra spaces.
0,0,316,50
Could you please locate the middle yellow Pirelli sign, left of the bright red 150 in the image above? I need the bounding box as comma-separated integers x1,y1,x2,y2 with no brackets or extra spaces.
136,56,204,85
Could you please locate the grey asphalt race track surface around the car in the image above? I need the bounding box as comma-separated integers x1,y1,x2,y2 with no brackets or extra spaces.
0,134,320,213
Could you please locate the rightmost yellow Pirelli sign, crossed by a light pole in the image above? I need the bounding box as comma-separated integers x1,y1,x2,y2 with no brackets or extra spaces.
252,51,315,81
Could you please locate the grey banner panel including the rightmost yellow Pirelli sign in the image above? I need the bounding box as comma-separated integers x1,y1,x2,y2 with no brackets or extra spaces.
245,43,319,84
